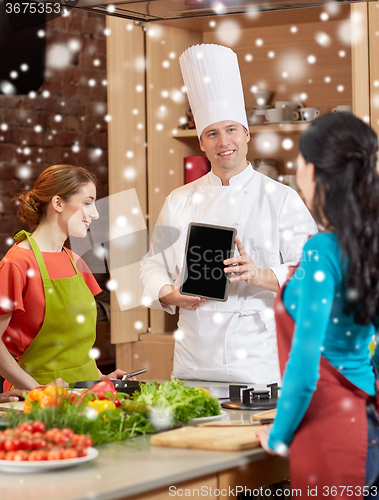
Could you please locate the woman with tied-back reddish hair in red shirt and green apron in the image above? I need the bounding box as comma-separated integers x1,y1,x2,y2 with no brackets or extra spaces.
0,165,129,390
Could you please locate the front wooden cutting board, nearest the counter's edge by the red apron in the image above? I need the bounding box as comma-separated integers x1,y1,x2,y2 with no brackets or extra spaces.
150,425,263,451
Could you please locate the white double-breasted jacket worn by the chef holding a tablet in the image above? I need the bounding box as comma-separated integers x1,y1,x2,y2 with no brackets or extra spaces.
140,164,317,384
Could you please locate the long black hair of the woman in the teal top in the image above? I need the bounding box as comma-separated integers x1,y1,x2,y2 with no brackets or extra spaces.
299,113,379,325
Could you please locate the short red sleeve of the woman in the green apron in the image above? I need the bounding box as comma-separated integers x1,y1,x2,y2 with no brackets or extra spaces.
0,258,26,314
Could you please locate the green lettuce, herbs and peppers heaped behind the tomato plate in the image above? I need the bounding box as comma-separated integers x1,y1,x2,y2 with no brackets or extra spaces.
4,380,220,445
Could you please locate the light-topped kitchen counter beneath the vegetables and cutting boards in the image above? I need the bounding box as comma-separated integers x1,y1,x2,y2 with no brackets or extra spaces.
0,381,288,500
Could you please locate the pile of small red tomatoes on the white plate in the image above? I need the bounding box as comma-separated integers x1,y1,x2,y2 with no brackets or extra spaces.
0,420,92,462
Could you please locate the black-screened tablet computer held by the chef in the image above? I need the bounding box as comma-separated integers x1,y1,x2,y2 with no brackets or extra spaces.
180,222,237,302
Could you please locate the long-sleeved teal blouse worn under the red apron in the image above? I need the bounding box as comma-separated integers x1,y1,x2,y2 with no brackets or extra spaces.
268,233,379,453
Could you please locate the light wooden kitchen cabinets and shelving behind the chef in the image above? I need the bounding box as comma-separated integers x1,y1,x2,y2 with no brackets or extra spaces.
107,3,379,378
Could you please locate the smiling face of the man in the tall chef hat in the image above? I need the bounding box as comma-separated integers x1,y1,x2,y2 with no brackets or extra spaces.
200,120,250,182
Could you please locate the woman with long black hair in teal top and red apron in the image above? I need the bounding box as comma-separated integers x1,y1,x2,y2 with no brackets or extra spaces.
259,113,379,498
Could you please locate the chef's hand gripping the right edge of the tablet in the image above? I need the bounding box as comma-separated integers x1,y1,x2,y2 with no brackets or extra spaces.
224,236,279,292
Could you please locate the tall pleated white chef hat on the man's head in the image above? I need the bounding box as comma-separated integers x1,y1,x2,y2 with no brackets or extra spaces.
179,44,249,138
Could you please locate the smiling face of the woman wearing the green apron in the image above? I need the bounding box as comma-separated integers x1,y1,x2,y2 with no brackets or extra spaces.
62,182,99,238
